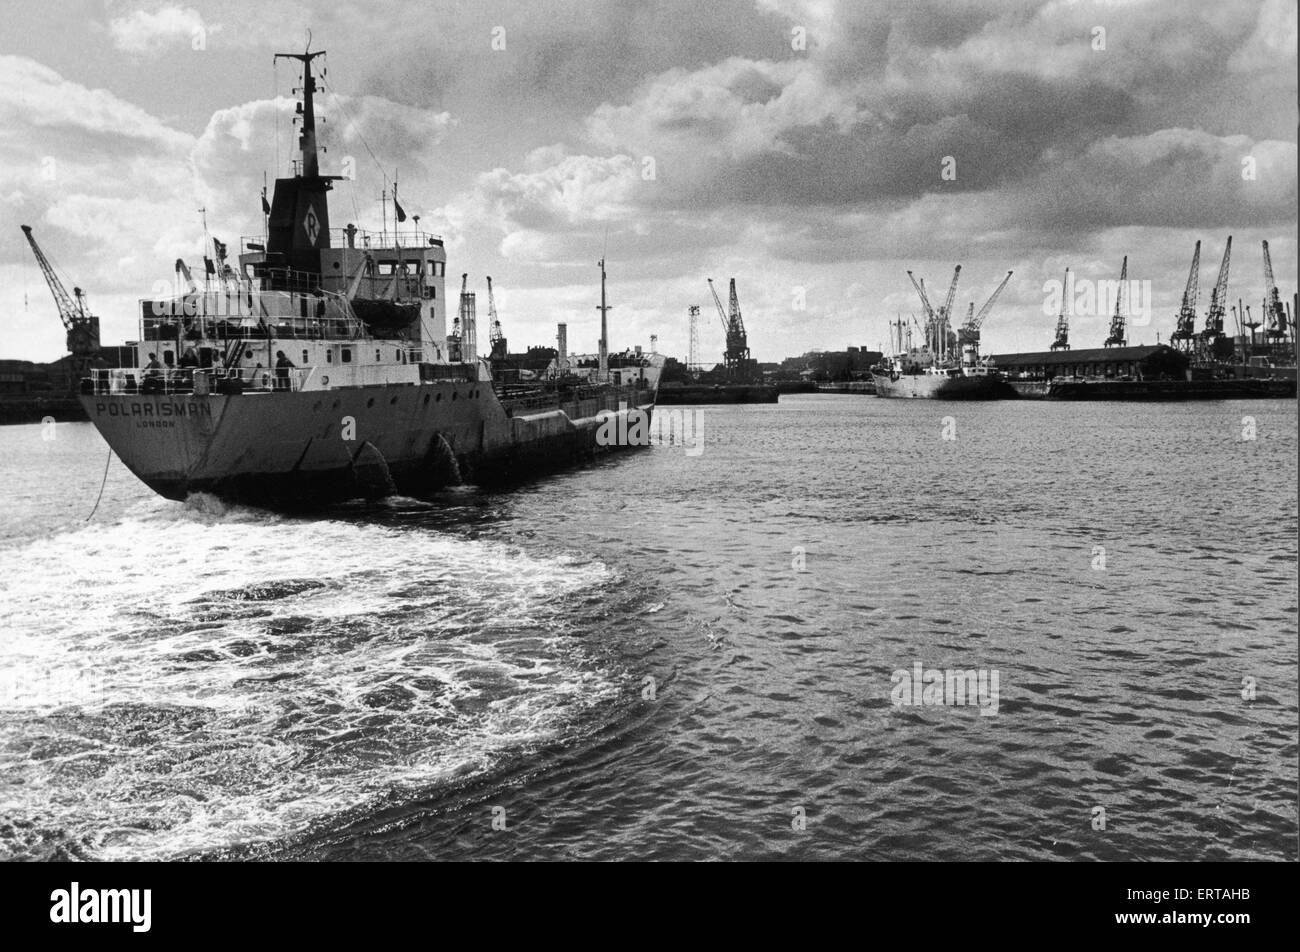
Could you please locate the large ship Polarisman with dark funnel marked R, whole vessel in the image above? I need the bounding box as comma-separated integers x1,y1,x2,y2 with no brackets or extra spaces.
79,48,663,507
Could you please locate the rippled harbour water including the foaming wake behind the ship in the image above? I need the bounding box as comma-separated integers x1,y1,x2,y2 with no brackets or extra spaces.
0,395,1297,860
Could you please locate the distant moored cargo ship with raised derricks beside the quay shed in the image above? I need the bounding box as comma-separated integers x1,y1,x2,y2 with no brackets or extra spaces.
872,264,1015,401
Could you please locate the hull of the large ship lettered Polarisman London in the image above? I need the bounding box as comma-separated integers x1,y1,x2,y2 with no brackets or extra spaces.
81,381,654,509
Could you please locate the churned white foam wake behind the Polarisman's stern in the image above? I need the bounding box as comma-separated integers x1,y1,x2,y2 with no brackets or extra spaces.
0,499,619,858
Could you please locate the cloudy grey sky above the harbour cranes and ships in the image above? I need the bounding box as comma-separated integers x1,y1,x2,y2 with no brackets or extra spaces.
0,0,1297,360
